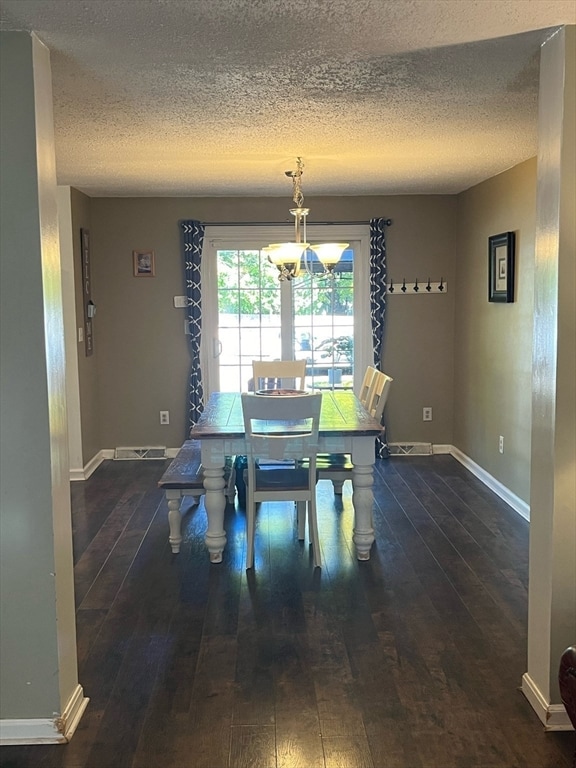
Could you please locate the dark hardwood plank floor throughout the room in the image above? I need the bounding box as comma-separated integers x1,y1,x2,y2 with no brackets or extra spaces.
0,456,574,768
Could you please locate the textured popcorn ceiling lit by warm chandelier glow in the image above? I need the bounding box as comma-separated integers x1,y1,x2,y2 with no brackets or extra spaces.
0,0,576,196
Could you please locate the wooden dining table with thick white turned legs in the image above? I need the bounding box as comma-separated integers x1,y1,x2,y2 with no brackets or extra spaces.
190,390,382,563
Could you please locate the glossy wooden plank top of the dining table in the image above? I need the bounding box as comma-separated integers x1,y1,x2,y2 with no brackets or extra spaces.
190,390,382,440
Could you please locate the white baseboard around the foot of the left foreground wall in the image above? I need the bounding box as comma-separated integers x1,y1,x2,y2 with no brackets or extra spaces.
0,685,90,746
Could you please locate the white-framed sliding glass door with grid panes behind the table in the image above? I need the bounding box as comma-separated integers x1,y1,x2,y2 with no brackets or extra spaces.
202,228,371,392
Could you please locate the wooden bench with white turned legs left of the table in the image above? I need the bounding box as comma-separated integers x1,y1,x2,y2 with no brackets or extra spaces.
158,440,235,553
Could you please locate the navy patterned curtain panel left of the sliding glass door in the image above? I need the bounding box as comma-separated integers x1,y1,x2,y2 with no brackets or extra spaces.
180,220,205,439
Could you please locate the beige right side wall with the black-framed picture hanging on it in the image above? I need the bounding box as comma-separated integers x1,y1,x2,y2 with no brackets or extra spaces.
454,158,536,503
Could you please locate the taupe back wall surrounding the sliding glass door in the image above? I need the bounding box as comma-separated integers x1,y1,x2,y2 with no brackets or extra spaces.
83,195,457,452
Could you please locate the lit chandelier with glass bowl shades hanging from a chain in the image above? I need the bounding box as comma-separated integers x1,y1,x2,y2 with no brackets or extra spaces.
262,157,348,280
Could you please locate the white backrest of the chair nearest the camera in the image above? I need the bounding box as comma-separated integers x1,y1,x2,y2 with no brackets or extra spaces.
242,392,322,465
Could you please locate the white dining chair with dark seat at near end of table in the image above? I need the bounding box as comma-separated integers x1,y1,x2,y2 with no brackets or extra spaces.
242,393,322,568
